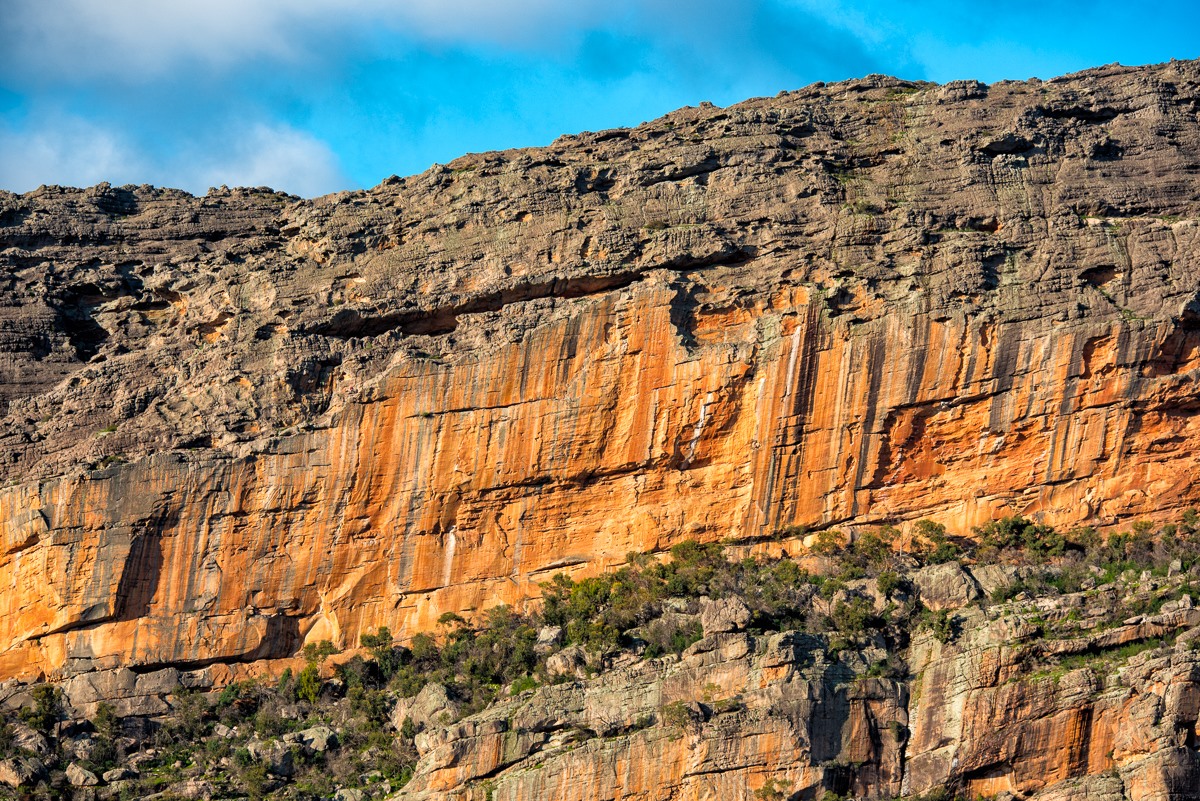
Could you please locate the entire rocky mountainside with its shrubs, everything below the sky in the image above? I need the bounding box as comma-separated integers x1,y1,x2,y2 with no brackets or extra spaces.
0,62,1200,801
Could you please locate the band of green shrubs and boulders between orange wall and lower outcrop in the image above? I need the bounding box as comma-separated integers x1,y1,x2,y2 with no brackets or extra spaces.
0,512,1200,800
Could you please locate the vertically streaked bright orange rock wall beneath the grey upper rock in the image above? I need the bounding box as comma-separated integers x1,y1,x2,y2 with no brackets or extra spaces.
0,281,1200,675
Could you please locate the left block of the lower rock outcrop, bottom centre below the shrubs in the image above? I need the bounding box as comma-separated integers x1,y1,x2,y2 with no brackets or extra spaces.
400,633,908,801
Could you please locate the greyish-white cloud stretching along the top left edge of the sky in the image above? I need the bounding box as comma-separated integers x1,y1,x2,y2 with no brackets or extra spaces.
0,0,595,80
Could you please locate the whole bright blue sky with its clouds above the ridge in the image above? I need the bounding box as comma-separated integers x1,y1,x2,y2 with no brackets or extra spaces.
0,0,1200,197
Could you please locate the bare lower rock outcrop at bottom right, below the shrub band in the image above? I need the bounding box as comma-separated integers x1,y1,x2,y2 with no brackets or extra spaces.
386,566,1200,801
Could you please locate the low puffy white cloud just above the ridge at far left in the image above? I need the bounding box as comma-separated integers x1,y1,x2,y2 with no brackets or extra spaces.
0,115,349,197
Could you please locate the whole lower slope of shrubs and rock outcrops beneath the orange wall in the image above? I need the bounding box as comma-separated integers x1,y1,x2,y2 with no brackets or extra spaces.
9,537,1200,801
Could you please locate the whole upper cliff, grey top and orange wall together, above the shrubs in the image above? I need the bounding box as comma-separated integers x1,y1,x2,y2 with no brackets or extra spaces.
0,62,1200,676
